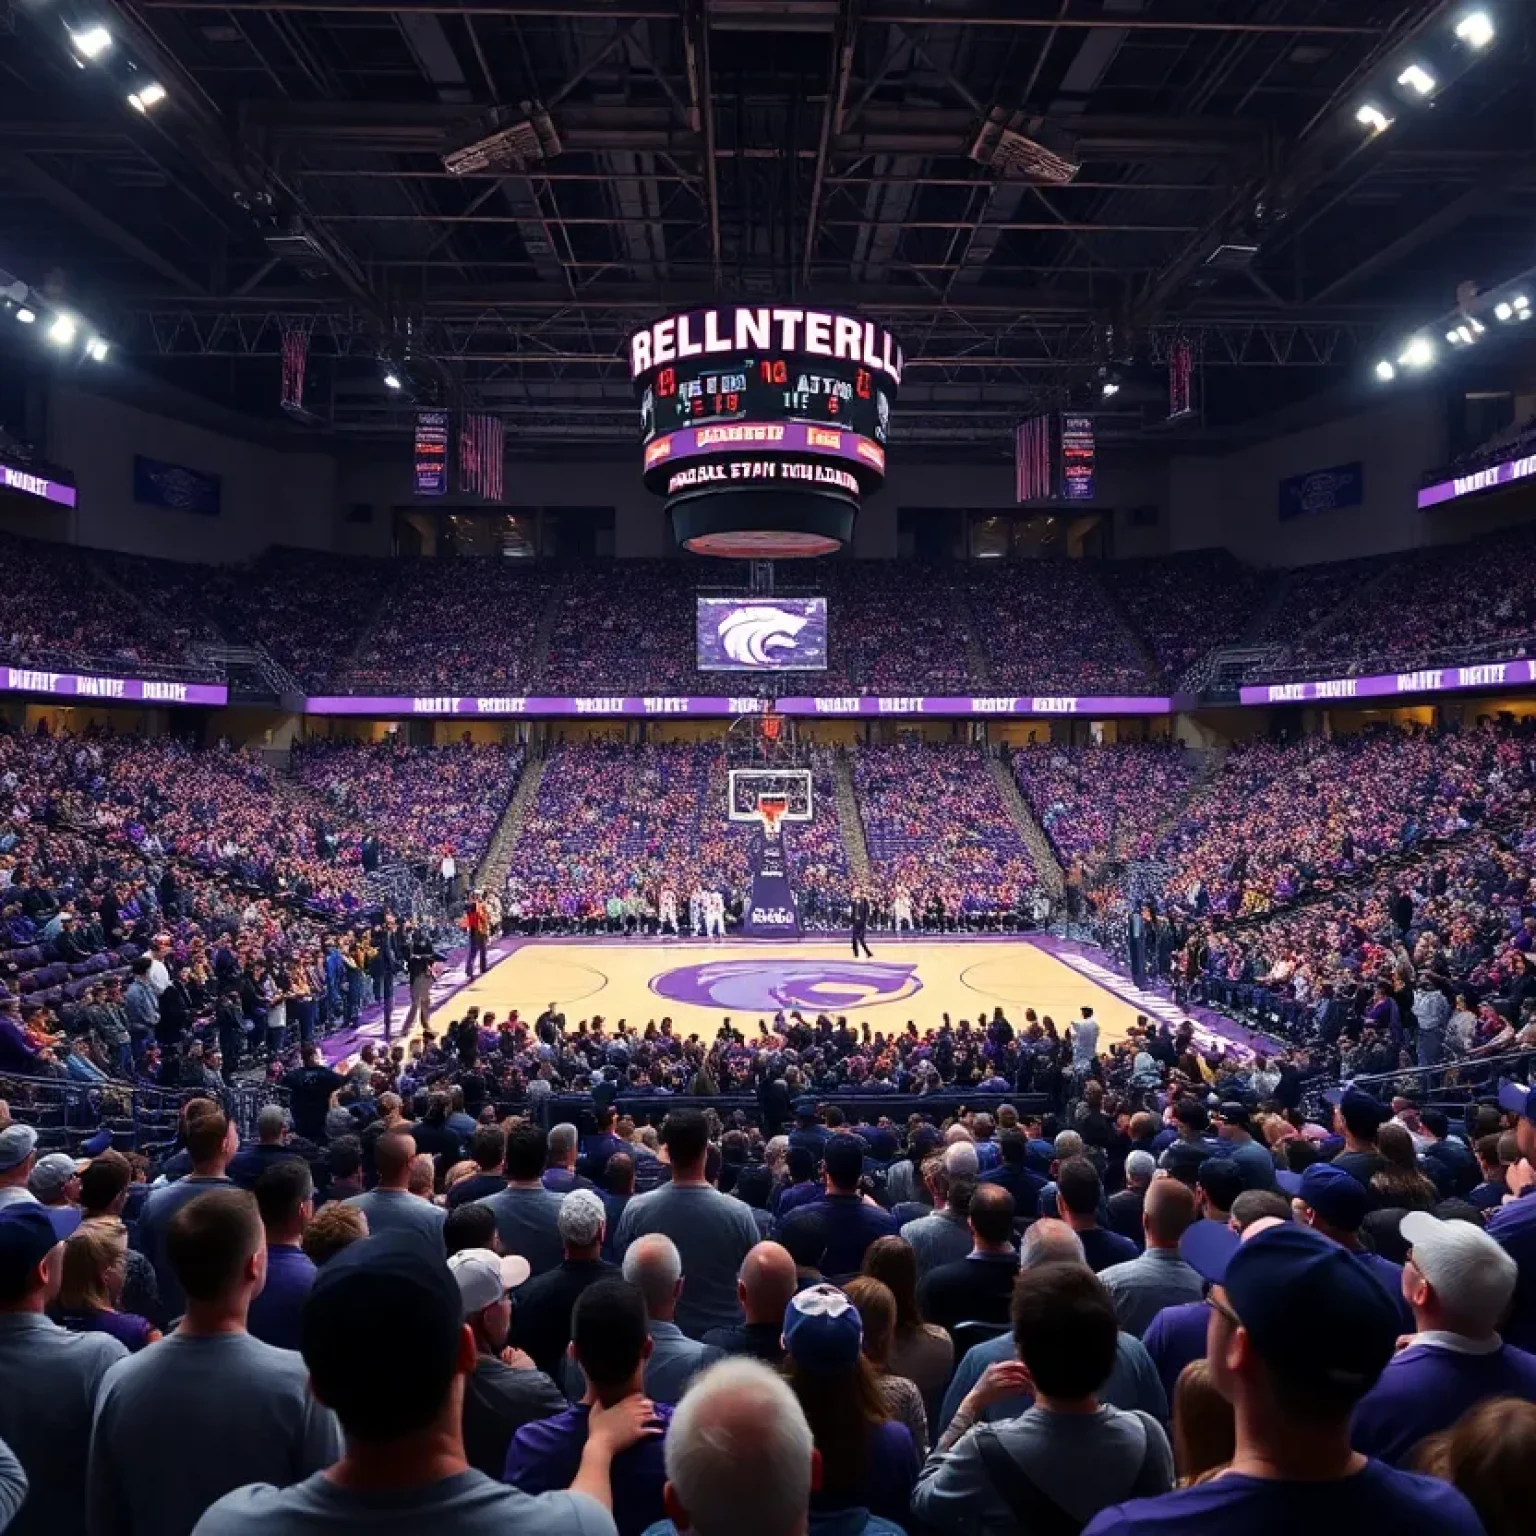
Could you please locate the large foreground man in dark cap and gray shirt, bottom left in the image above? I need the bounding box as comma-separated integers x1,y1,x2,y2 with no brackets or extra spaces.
197,1232,629,1536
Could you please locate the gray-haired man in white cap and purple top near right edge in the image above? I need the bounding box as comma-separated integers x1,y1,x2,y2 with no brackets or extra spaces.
1353,1210,1536,1465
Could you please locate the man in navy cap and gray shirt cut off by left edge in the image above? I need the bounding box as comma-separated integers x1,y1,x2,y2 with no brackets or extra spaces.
0,1201,127,1536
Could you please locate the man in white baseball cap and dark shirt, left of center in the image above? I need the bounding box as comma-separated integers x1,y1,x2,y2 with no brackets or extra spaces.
449,1249,565,1478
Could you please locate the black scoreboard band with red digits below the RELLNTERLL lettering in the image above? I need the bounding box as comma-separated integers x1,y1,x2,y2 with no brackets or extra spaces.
641,355,891,444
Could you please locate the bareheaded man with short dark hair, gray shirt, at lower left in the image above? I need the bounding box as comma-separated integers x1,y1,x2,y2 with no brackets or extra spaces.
88,1189,341,1536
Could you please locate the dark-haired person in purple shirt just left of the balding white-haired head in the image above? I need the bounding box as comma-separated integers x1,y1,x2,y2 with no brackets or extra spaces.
505,1279,671,1536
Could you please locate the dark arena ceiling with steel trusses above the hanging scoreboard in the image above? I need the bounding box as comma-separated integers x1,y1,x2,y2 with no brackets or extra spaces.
0,0,1536,458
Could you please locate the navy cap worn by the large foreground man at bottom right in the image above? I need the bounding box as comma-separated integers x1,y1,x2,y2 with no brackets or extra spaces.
1185,1223,1402,1398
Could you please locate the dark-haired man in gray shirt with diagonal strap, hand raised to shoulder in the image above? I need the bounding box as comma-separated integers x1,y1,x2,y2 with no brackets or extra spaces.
912,1264,1174,1531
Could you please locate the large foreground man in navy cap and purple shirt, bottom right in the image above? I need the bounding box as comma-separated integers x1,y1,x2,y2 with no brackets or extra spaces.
1084,1220,1482,1536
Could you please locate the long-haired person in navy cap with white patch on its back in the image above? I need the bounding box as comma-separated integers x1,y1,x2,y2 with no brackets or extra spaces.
783,1286,917,1521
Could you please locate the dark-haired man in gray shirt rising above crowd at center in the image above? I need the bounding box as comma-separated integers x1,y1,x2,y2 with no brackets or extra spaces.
614,1109,757,1338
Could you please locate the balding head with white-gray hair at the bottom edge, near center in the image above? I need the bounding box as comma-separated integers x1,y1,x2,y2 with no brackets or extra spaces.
653,1358,817,1536
